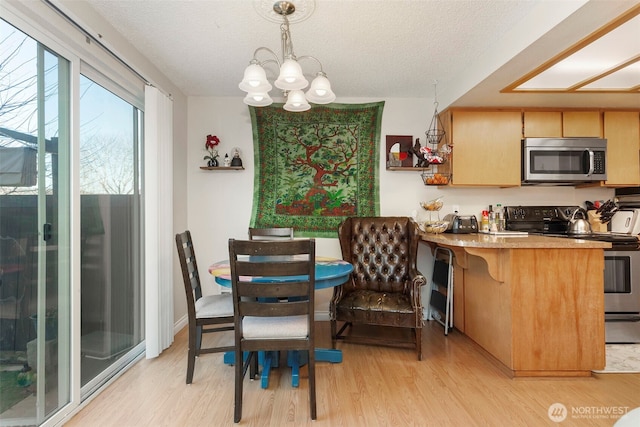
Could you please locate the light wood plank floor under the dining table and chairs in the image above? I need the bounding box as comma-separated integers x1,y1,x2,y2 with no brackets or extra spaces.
66,322,640,427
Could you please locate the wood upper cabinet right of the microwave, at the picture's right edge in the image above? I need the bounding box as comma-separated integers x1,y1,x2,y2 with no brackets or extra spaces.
604,111,640,186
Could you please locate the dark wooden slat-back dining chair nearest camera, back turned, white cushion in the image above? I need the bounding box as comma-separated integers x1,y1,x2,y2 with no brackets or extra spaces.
229,239,316,423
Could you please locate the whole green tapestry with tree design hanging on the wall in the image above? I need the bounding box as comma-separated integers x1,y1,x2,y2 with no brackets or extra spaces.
249,102,384,237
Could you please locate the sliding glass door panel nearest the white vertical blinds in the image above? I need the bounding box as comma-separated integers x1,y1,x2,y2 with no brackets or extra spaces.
80,70,143,395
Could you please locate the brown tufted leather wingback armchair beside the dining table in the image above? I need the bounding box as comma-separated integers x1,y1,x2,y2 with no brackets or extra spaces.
329,217,426,360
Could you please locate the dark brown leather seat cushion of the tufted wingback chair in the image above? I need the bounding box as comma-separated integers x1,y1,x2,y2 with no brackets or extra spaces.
337,289,415,314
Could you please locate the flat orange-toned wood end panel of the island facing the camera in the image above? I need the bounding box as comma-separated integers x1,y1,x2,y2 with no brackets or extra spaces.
509,249,605,376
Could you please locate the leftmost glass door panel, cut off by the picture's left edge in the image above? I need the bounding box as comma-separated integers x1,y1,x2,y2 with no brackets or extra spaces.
0,21,71,425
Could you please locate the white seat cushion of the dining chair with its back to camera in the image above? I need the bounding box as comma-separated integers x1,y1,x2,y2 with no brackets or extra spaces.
242,316,309,339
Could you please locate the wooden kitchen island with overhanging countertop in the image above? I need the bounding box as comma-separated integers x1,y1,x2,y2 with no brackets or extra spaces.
422,233,611,377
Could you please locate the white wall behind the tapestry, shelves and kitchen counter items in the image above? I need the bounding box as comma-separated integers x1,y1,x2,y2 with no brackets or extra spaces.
187,96,613,317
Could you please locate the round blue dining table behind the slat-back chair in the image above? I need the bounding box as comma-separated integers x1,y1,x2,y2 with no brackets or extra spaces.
209,256,353,388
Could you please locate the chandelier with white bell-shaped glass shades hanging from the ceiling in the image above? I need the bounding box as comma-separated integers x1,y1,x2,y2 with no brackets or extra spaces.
238,1,336,112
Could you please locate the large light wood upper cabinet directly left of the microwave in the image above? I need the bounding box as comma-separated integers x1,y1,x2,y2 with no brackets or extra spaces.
447,110,522,187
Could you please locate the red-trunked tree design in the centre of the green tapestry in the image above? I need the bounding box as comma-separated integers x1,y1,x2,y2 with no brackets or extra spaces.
275,123,359,216
